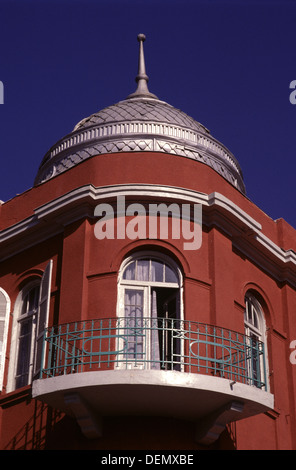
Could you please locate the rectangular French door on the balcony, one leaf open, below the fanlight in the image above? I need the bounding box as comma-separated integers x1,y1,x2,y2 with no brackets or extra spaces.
118,286,181,370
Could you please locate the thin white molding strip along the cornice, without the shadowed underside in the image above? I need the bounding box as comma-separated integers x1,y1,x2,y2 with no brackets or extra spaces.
0,184,296,274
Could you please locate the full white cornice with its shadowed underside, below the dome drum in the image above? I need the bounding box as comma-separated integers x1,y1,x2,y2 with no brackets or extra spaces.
0,184,296,285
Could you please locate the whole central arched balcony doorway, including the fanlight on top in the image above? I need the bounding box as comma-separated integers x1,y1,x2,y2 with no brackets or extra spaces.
118,254,182,370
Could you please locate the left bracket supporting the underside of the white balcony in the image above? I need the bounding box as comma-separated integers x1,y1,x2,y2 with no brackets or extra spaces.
64,393,102,439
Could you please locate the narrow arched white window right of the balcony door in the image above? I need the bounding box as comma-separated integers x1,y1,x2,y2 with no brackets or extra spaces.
245,293,266,388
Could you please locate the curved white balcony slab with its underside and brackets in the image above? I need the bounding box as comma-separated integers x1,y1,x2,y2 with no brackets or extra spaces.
32,369,274,444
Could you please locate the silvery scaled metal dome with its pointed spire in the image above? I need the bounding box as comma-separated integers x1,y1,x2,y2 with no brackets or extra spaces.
35,34,245,193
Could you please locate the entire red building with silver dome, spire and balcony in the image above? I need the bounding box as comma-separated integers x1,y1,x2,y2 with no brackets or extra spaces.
0,35,296,450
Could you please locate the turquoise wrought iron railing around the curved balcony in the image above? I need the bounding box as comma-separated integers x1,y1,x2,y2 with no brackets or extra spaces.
40,317,266,390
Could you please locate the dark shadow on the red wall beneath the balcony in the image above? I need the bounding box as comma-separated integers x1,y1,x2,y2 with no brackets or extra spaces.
3,401,236,450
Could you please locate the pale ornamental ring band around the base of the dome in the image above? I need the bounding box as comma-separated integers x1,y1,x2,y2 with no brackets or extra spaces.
35,119,245,193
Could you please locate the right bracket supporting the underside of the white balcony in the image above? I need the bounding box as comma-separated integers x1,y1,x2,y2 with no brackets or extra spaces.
195,401,244,445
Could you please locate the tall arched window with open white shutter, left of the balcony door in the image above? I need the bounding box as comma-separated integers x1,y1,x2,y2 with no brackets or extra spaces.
8,261,52,391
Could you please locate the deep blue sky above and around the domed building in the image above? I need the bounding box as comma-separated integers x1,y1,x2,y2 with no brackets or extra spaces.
0,0,296,228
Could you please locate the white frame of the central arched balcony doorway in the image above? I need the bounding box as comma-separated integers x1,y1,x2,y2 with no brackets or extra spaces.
116,251,184,369
